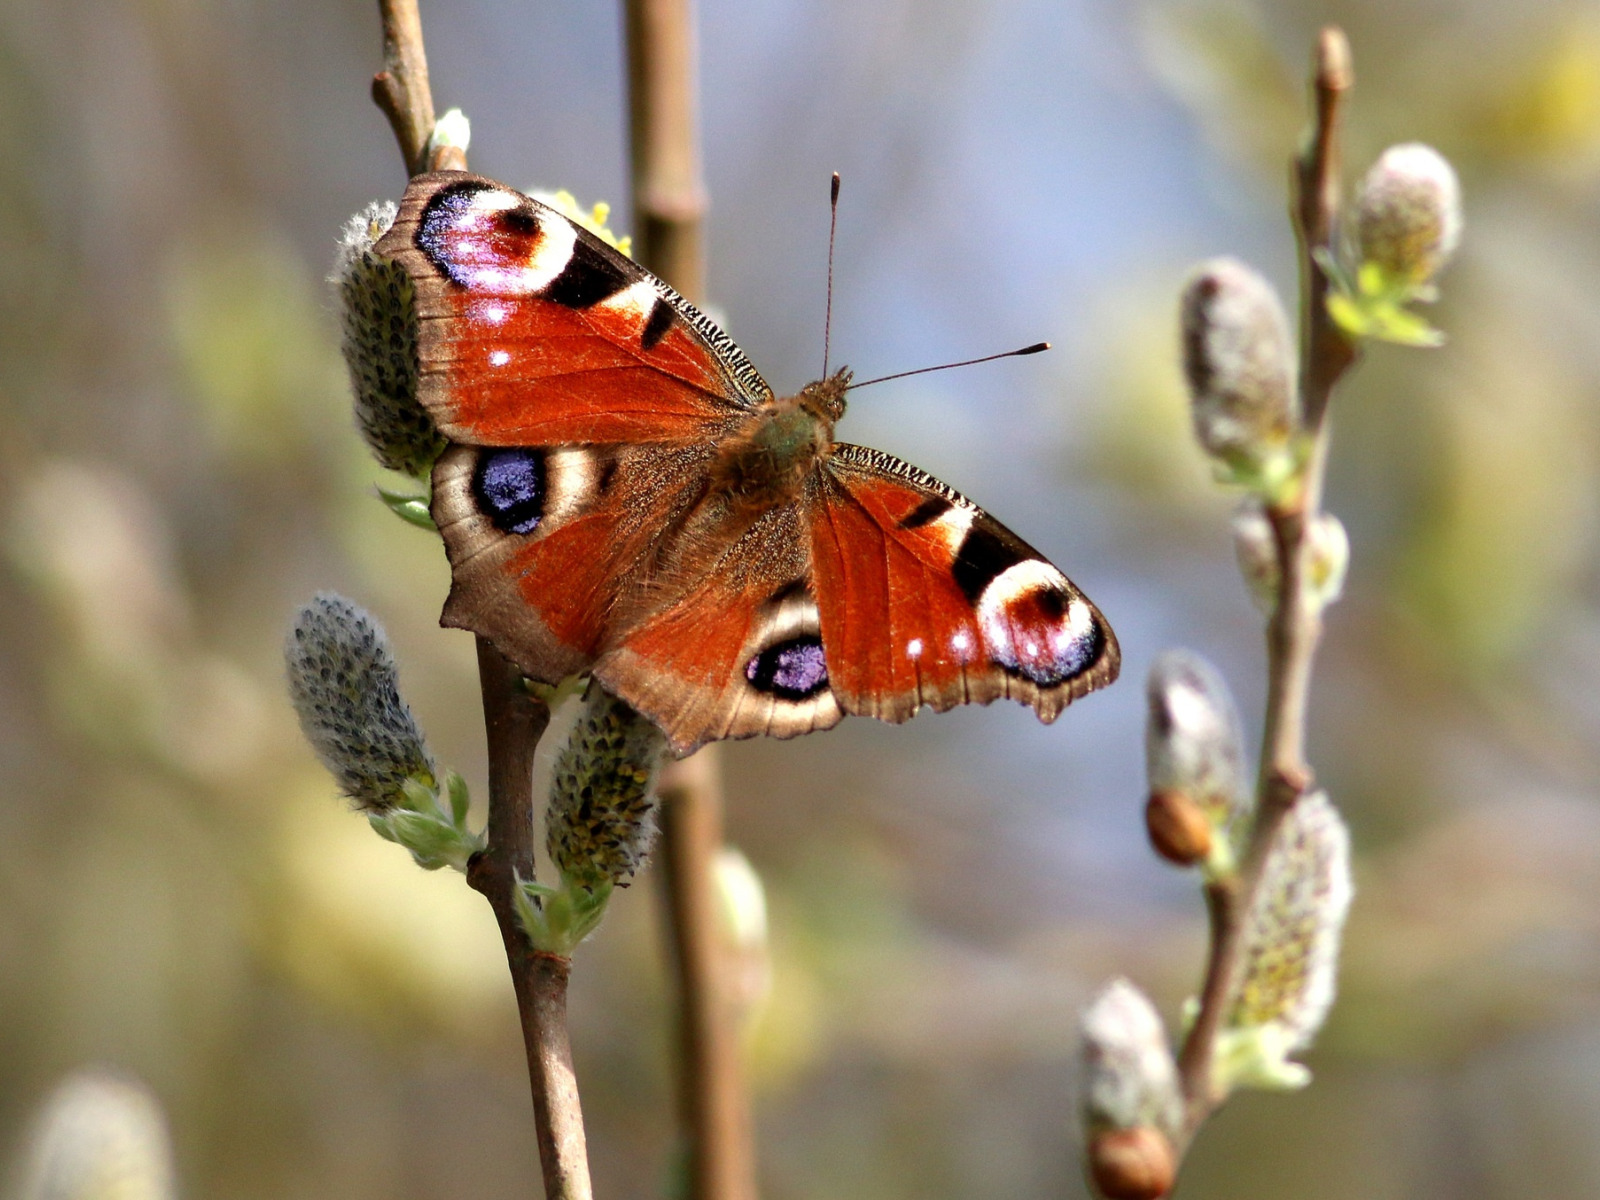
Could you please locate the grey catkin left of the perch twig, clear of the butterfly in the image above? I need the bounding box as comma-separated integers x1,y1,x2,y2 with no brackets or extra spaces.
283,592,438,813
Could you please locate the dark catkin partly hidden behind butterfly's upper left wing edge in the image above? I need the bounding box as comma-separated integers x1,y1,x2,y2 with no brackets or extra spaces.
330,200,445,478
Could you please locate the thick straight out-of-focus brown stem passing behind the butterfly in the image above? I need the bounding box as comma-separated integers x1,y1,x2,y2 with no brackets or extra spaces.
627,0,757,1200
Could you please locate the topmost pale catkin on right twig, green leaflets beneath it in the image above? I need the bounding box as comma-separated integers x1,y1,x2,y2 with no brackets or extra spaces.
1355,142,1461,286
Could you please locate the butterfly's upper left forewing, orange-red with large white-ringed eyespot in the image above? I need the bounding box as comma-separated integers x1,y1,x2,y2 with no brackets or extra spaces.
376,171,771,446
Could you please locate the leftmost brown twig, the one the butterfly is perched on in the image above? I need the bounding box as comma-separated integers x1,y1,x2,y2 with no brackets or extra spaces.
373,0,592,1200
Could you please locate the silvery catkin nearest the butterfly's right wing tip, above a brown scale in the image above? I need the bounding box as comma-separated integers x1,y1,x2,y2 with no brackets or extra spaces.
1144,650,1250,872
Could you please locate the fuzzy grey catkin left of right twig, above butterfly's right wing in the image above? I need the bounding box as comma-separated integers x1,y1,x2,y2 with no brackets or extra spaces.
1179,258,1299,493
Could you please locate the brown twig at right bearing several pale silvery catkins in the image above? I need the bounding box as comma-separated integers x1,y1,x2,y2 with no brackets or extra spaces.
1178,27,1355,1154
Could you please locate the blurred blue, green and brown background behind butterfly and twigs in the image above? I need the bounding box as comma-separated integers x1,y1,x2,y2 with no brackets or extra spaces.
0,0,1600,1200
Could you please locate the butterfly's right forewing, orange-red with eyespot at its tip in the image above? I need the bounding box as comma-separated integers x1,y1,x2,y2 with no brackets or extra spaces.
810,443,1120,722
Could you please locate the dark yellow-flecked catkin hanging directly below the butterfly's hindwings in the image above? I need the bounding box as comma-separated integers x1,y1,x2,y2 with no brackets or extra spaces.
546,680,667,888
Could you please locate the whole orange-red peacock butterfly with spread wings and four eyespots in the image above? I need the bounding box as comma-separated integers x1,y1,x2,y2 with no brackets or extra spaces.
376,171,1120,754
